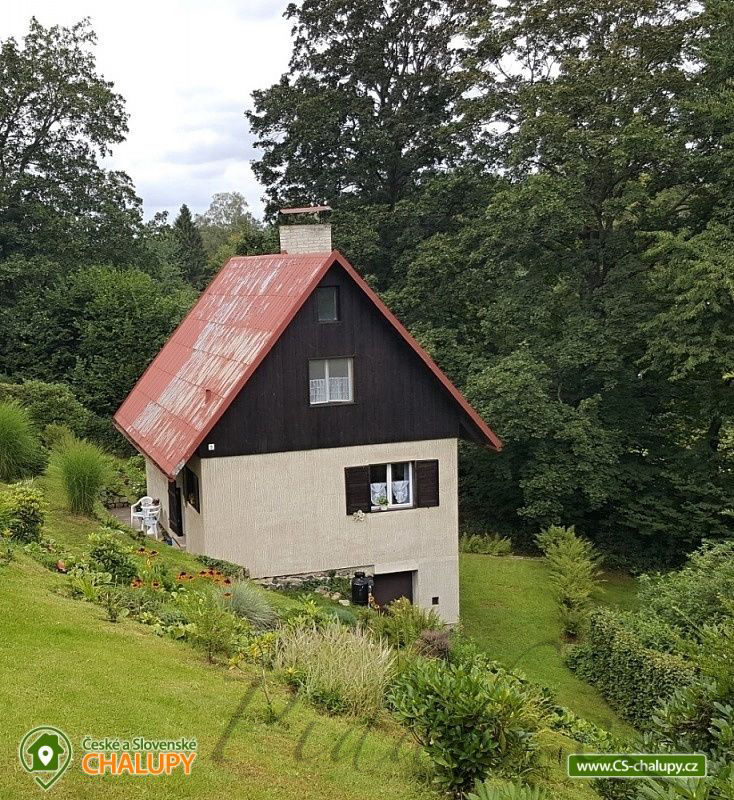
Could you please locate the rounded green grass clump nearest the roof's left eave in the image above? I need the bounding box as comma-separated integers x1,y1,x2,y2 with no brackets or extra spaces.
49,437,109,516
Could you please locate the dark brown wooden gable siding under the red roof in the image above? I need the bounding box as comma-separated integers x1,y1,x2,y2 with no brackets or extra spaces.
199,265,465,458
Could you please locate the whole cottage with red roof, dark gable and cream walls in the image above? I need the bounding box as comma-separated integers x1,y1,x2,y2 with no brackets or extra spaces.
115,207,501,622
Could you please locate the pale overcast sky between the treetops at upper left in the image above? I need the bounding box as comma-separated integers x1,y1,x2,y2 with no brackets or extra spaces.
5,0,290,217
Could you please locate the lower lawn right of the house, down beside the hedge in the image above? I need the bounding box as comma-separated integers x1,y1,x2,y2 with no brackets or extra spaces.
461,554,634,733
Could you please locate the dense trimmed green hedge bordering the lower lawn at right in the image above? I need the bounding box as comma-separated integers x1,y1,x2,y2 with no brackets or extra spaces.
568,609,696,729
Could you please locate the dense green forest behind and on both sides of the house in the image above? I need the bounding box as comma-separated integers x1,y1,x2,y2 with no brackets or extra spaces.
0,0,734,566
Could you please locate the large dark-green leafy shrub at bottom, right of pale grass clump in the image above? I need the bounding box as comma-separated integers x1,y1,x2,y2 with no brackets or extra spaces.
389,660,537,794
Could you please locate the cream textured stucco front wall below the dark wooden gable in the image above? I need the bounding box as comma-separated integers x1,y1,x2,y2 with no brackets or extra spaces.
196,439,459,622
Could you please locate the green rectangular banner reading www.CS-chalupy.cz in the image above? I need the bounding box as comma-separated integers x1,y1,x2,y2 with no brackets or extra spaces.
568,753,706,778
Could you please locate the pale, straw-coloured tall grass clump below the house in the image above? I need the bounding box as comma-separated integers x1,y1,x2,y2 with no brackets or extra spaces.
275,620,395,719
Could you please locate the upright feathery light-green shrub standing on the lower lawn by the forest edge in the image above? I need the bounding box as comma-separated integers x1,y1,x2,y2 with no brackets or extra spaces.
536,525,601,637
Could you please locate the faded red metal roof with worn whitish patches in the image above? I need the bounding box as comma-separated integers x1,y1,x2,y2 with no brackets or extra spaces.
114,250,502,478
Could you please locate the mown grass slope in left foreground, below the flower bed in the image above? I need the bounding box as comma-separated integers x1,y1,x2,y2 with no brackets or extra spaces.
0,558,430,800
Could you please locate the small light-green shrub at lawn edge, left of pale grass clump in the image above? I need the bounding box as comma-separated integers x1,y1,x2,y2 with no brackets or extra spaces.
177,590,246,663
